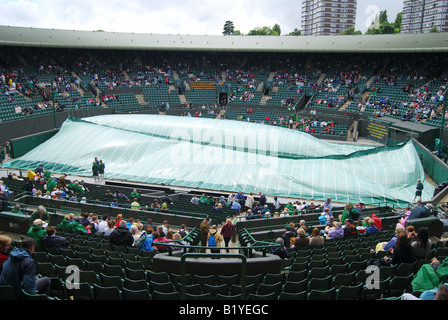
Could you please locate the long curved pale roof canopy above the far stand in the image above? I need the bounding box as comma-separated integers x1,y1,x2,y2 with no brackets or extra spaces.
0,26,448,53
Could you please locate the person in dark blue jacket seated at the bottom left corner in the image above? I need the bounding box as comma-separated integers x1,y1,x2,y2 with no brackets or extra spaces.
0,238,50,297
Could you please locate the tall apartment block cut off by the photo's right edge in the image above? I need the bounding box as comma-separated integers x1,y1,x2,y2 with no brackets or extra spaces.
401,0,448,33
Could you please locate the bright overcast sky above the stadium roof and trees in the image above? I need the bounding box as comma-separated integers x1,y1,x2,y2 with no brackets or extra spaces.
0,0,403,35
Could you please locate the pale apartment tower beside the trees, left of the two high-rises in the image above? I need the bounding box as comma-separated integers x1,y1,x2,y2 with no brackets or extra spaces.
301,0,357,35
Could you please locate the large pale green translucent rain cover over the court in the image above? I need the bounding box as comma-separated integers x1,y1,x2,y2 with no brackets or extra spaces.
5,114,434,205
